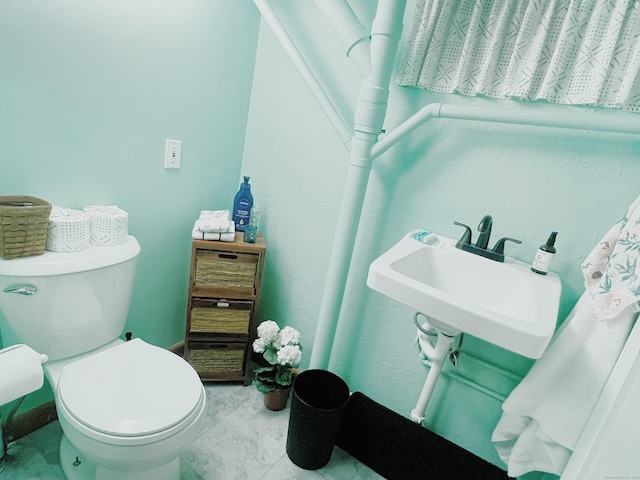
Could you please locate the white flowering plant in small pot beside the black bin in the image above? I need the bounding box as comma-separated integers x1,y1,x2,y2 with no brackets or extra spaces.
253,320,302,410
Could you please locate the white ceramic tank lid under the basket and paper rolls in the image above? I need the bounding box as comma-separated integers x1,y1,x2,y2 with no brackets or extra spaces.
0,235,140,277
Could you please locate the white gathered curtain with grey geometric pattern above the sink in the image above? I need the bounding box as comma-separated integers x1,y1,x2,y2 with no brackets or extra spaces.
396,0,640,112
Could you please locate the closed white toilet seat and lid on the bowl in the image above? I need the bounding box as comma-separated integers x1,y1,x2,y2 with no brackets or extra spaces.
57,339,204,443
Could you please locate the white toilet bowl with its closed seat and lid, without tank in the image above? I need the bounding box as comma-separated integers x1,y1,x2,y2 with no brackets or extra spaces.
50,339,206,480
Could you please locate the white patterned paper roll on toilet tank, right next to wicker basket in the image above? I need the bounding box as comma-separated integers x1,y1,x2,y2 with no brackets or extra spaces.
45,205,91,252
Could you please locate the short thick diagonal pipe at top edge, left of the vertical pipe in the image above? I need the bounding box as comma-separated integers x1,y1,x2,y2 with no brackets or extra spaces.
315,0,371,78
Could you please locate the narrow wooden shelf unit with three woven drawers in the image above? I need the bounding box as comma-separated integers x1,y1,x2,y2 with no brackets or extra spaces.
184,232,267,385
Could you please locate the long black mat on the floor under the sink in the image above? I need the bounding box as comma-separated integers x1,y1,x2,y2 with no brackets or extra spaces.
337,392,510,480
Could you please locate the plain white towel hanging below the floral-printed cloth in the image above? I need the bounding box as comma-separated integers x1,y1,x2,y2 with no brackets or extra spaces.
491,293,636,477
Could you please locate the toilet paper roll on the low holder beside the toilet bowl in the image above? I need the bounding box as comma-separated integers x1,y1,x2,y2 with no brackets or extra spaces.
0,345,47,405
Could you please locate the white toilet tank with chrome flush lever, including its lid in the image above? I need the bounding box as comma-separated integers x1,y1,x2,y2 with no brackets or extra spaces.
0,236,140,360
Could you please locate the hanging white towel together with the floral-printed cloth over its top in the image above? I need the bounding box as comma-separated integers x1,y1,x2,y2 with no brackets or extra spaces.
491,197,640,477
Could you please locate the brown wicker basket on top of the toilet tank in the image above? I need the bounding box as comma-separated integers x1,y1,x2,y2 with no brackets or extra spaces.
0,195,51,260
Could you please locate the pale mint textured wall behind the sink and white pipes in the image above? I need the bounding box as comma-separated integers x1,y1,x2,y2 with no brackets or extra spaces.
242,2,640,474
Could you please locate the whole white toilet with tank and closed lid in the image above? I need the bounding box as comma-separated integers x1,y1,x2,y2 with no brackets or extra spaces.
0,236,205,480
